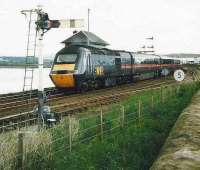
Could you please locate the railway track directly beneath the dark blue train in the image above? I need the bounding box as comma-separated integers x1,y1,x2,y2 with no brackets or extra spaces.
0,77,170,118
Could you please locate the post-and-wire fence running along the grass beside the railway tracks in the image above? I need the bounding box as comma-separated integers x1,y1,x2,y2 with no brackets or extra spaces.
0,81,199,170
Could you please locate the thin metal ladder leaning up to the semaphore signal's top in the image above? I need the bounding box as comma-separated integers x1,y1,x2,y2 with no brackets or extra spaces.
22,10,38,101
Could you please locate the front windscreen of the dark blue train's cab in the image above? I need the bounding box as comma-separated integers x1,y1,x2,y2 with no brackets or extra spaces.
56,54,77,63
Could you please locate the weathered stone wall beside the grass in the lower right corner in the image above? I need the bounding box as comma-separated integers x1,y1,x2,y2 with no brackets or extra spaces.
150,91,200,170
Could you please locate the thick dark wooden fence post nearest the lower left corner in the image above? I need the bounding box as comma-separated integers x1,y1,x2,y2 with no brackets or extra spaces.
17,132,24,170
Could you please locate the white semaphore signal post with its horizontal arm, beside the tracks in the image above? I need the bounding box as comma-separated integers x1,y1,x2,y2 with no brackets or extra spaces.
21,7,84,129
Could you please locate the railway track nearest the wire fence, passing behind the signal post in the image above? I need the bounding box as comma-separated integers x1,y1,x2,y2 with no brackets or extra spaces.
0,79,177,131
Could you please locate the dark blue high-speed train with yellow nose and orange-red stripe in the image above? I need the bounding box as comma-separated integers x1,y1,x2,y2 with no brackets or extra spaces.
50,45,180,91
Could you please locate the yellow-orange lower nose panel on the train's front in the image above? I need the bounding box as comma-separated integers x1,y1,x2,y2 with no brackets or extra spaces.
50,74,75,88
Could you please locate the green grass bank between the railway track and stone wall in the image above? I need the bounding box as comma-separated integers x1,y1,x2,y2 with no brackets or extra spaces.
10,83,199,170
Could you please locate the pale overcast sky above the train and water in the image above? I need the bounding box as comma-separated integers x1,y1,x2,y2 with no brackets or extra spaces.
0,0,200,56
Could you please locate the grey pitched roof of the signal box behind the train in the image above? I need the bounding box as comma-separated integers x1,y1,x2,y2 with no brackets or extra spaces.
61,31,109,47
